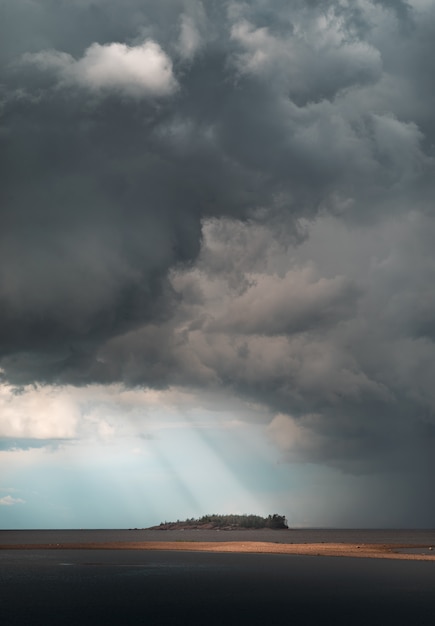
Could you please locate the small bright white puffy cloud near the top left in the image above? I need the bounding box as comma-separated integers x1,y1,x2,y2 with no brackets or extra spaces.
23,40,178,97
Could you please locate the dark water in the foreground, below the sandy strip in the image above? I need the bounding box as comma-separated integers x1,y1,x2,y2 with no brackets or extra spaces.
0,531,435,626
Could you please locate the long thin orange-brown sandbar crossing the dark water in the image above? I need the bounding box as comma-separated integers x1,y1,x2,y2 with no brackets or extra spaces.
0,541,435,561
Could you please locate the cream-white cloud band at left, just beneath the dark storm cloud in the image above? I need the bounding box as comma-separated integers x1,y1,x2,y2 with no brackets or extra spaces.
0,384,264,444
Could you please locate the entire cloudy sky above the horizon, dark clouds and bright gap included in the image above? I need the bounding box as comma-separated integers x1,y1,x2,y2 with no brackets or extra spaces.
0,0,435,529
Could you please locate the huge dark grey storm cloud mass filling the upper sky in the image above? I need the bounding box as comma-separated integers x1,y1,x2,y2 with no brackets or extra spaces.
0,0,435,482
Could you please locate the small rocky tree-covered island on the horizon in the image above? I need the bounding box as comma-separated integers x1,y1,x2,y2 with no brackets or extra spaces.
146,513,288,530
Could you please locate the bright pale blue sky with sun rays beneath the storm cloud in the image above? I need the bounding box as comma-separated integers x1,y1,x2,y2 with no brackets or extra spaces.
0,386,426,529
